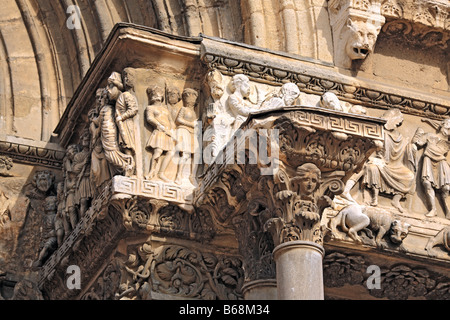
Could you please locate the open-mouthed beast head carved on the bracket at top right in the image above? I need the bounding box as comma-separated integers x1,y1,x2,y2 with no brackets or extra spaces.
345,19,381,60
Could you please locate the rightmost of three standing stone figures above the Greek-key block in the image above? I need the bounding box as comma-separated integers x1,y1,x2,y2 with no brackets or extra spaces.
175,88,198,184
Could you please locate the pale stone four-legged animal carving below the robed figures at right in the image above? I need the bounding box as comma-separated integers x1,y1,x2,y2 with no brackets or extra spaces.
330,204,411,247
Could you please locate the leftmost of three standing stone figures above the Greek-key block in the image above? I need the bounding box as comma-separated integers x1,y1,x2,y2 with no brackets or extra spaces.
145,86,175,182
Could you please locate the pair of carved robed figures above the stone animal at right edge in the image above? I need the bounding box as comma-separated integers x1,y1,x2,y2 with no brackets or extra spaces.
342,109,450,219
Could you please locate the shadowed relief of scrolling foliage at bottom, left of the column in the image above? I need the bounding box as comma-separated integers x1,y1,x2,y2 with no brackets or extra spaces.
82,241,243,300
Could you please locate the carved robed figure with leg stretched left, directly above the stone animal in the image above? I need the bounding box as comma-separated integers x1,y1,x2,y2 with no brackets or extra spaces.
342,109,416,212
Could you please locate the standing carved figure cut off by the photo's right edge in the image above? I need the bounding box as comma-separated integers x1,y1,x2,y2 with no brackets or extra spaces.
413,119,450,219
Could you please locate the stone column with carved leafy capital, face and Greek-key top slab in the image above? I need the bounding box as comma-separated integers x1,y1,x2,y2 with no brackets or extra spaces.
195,107,383,300
